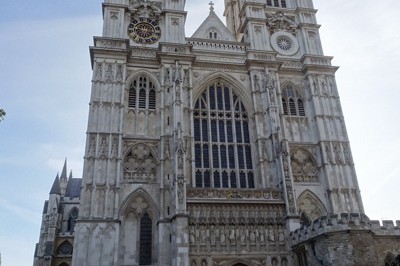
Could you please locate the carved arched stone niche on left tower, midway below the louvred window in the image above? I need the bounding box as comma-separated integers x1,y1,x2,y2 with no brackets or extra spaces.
123,143,157,182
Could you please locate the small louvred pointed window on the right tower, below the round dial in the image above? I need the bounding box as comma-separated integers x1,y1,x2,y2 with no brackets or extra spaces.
282,84,306,116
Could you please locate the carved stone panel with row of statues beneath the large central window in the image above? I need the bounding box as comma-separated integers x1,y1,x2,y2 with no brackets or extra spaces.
188,204,286,255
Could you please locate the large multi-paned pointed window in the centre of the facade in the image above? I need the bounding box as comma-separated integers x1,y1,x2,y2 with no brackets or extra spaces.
193,82,254,188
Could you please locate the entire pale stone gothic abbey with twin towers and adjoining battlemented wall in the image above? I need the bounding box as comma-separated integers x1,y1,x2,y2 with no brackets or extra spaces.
34,0,400,266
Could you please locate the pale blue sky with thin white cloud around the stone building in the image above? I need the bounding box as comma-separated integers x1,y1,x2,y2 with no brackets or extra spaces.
0,0,400,266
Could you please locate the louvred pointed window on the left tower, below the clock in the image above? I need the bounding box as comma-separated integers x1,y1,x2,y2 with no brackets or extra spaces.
128,76,156,110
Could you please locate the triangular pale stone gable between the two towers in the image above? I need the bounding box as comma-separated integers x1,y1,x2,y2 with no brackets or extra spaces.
191,8,236,42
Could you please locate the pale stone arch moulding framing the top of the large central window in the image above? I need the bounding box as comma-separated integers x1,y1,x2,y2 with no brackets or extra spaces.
192,71,254,117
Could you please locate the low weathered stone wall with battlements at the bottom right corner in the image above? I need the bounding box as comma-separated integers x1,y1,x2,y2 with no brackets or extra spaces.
291,214,400,266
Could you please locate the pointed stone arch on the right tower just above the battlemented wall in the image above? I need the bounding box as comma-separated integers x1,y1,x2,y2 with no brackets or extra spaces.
297,189,327,224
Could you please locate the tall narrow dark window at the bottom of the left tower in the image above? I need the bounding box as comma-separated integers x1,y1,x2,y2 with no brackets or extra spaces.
139,213,153,265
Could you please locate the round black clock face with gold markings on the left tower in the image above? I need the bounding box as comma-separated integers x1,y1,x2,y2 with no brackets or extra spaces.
128,18,161,44
